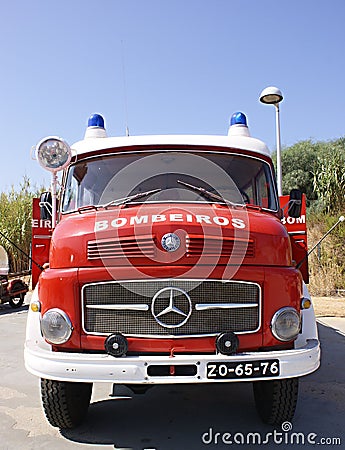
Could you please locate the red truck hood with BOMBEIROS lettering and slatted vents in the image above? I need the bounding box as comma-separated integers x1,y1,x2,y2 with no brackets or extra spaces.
50,203,291,268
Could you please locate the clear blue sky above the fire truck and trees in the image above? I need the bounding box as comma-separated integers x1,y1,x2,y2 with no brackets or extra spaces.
0,0,345,192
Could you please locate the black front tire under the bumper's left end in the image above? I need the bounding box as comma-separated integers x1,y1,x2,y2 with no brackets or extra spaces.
41,378,92,429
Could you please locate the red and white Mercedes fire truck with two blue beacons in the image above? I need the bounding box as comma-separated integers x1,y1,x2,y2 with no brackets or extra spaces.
25,113,320,429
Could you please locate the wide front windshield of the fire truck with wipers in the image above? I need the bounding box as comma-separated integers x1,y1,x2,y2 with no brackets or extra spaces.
62,150,277,212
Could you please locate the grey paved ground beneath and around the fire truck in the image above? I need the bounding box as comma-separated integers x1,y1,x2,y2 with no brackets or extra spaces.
0,305,345,450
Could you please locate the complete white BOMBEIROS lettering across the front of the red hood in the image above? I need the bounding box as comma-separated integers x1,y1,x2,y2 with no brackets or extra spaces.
94,213,246,232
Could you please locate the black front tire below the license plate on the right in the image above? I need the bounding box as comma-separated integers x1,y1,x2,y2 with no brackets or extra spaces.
253,378,298,425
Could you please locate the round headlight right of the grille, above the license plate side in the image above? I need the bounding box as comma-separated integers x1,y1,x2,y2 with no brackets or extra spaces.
271,306,301,342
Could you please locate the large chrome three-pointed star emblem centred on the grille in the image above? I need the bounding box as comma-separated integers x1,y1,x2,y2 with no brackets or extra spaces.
151,287,192,328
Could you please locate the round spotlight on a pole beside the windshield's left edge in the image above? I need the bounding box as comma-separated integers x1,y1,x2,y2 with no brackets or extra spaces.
36,136,72,172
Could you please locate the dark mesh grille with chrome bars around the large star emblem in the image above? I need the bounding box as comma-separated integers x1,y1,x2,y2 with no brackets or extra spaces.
82,279,261,337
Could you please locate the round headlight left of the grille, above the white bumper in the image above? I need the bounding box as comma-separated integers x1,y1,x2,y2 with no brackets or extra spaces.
41,309,73,344
